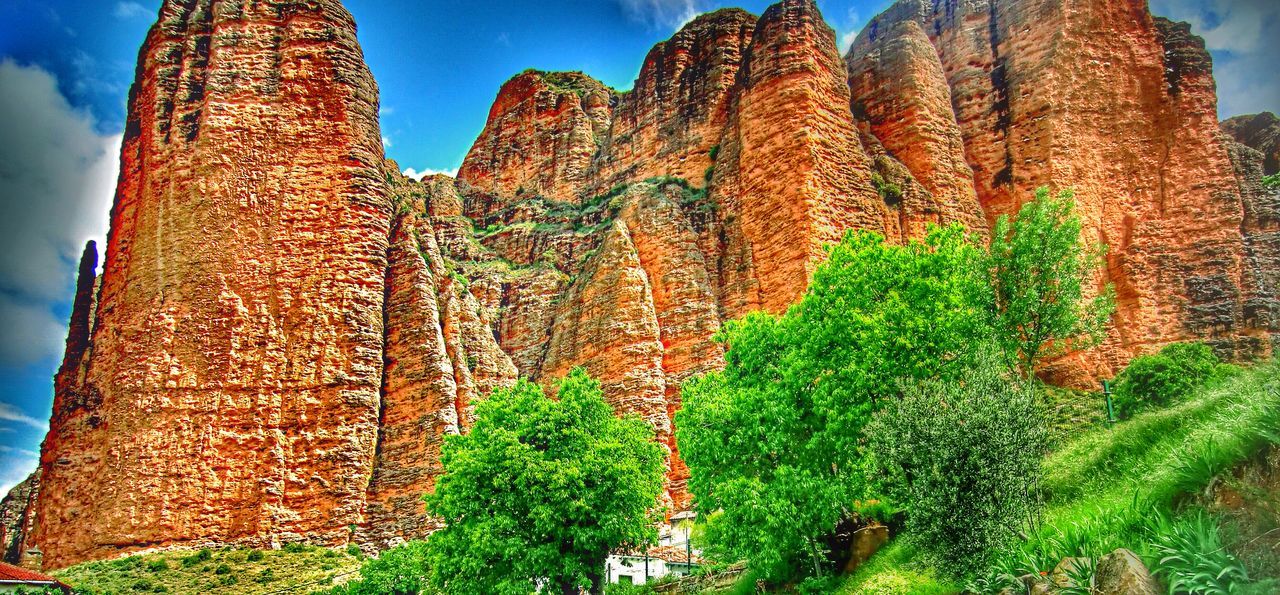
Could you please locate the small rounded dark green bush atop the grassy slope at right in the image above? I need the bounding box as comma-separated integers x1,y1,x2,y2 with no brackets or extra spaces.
1112,343,1230,416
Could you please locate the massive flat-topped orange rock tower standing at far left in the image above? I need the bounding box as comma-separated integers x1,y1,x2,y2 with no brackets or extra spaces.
35,0,390,568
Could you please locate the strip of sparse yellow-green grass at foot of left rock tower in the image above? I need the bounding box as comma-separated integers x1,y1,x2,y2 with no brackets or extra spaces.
54,546,362,595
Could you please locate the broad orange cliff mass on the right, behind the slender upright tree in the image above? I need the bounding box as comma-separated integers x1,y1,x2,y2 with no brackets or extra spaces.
847,0,1276,384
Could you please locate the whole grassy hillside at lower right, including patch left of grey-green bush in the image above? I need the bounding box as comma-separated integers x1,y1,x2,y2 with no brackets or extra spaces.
840,363,1280,594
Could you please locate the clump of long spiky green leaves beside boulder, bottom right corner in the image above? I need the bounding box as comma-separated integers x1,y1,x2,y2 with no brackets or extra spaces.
1147,511,1249,595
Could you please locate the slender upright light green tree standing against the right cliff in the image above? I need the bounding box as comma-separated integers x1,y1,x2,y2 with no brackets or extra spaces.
991,188,1114,376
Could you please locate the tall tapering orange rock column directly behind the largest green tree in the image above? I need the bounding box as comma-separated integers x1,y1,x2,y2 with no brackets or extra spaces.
713,0,887,316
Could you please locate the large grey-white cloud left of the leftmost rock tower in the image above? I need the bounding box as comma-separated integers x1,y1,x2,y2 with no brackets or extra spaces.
0,60,120,365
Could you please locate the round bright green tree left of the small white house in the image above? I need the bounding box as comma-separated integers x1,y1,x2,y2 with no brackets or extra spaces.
426,369,663,595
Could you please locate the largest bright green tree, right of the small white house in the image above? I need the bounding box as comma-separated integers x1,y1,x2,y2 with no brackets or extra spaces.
676,226,991,578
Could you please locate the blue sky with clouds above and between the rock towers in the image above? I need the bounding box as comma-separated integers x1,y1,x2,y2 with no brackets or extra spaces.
0,0,1280,490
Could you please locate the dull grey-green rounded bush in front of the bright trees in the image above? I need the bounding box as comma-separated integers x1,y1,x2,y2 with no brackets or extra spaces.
867,353,1046,569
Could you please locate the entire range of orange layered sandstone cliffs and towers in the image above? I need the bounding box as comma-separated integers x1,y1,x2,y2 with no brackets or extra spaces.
0,0,1280,568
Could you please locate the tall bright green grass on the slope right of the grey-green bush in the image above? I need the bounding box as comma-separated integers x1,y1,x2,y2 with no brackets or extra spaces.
991,363,1280,581
